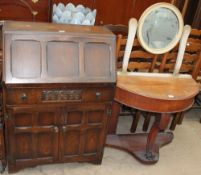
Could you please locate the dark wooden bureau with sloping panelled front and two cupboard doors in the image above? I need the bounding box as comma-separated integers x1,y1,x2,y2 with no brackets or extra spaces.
1,21,116,173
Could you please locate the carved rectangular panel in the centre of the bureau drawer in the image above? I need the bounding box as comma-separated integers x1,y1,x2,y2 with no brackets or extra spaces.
41,90,82,102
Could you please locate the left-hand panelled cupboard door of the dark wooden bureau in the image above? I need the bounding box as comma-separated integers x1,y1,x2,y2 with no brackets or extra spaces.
6,108,59,166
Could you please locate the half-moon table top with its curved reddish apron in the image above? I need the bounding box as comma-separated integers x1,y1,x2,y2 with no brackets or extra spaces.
115,74,199,112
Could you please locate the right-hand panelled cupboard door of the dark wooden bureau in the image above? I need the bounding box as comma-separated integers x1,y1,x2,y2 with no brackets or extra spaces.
61,104,108,161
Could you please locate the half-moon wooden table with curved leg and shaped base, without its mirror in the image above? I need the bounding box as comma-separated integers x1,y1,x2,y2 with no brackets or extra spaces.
106,75,199,164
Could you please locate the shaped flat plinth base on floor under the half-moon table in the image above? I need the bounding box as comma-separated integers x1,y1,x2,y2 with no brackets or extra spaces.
106,132,173,164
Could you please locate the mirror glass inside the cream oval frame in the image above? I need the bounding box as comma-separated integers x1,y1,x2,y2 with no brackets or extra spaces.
142,7,179,49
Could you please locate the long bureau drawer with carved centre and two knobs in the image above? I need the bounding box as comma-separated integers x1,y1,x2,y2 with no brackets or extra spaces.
5,87,114,105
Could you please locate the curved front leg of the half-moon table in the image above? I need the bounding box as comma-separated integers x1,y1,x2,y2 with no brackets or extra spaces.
145,113,171,160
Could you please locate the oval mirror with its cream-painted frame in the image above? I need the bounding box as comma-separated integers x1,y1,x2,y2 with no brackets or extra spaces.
137,3,184,54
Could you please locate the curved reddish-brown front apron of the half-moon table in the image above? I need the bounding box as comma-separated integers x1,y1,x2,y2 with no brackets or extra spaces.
115,87,194,113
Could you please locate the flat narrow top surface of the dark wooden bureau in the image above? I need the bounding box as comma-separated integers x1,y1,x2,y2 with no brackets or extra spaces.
4,21,115,37
